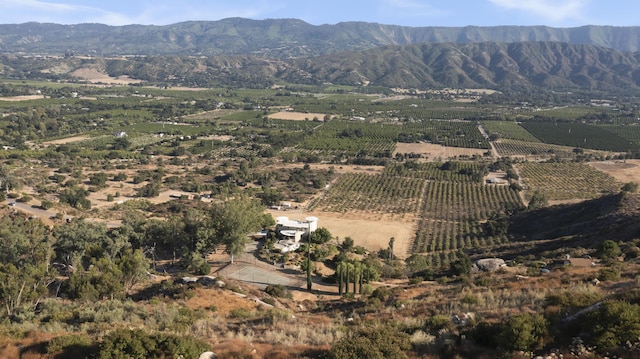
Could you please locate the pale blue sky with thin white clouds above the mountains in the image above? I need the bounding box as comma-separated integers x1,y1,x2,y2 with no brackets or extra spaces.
0,0,640,27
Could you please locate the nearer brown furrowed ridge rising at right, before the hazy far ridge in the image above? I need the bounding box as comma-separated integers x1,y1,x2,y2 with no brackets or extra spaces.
281,42,640,90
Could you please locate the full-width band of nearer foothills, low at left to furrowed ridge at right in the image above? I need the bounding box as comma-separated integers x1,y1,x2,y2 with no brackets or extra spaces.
0,42,640,92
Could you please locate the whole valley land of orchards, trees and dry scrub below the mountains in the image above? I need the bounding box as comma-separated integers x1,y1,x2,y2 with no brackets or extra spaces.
0,79,640,358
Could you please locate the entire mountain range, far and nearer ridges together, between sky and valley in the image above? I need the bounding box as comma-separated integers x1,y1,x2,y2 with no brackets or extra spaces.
0,18,640,91
